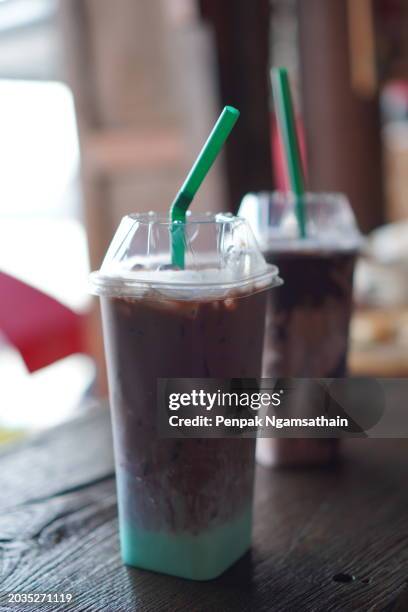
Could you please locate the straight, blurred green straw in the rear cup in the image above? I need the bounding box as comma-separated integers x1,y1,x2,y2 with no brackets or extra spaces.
271,68,306,238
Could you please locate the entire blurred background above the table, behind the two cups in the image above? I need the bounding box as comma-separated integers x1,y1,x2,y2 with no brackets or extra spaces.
0,0,408,440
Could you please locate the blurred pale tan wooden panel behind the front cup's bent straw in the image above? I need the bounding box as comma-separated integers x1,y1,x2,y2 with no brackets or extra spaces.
60,0,223,268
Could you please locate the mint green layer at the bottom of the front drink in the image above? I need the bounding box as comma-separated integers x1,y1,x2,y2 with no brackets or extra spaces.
120,508,252,580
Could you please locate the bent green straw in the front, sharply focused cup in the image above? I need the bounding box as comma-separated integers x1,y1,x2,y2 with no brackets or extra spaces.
170,106,239,269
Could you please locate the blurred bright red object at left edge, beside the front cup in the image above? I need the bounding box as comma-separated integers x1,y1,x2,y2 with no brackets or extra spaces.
0,272,87,372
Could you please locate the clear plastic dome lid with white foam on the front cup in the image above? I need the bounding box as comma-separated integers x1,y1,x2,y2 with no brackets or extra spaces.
90,213,281,300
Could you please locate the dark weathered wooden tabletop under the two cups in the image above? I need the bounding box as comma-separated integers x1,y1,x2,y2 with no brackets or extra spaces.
0,407,408,612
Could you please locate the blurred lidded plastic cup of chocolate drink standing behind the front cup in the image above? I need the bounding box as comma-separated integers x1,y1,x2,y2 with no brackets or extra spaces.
239,193,361,465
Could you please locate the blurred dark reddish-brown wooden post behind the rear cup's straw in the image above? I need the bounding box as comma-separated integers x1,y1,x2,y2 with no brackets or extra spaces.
298,0,384,232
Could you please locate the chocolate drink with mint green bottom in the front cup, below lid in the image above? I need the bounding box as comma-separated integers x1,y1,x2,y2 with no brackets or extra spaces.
101,291,269,579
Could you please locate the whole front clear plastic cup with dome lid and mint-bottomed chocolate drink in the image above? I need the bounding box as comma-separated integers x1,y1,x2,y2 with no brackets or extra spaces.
91,213,280,580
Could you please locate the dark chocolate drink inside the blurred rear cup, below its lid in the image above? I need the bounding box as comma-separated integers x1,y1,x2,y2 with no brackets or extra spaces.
257,249,356,465
